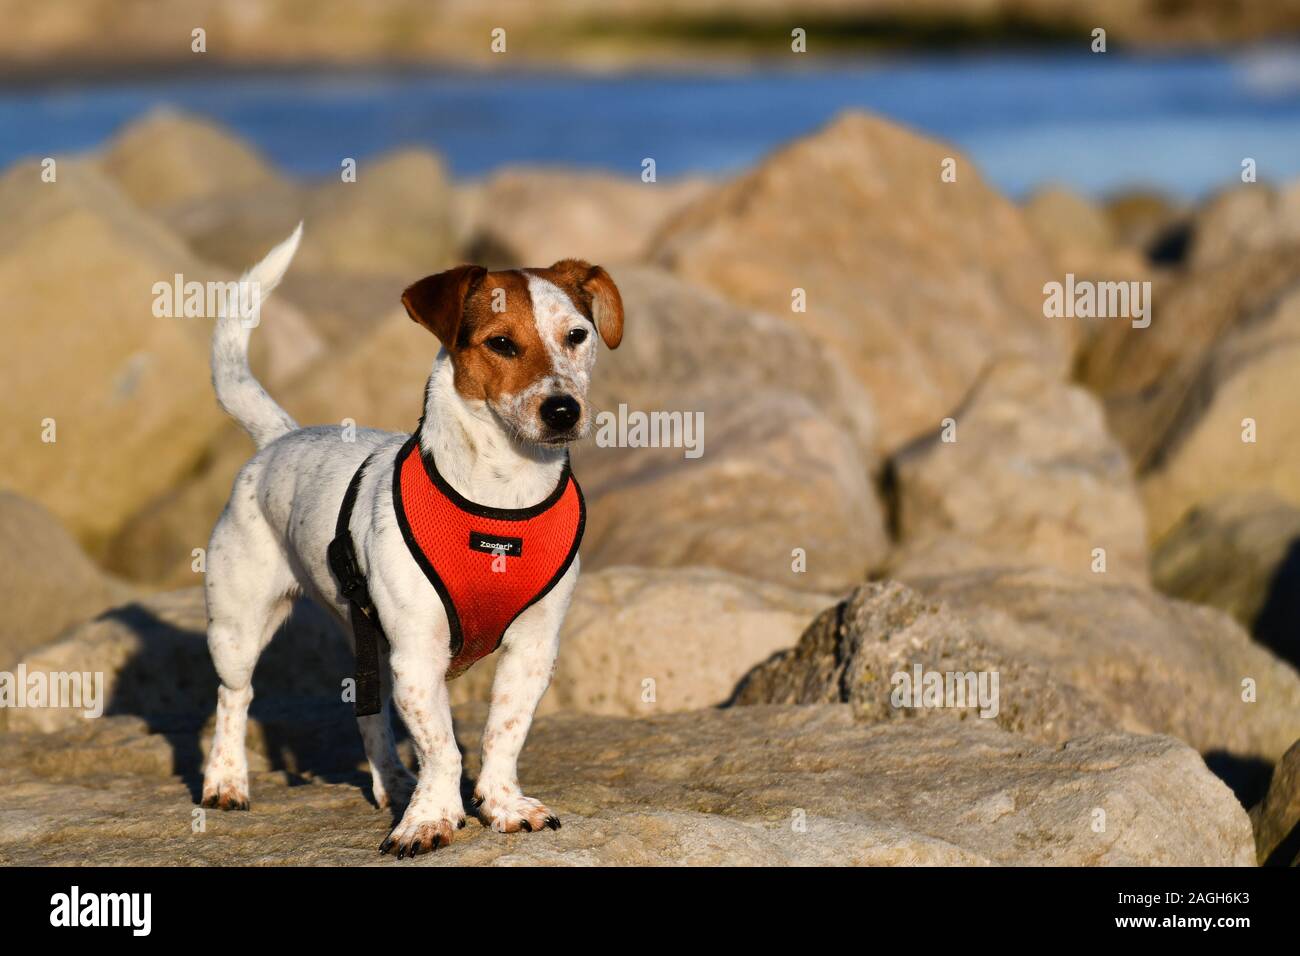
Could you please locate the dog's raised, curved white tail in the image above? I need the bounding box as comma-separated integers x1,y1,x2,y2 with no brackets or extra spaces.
212,222,303,449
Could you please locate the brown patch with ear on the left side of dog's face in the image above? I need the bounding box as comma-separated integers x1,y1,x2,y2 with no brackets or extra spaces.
402,265,551,402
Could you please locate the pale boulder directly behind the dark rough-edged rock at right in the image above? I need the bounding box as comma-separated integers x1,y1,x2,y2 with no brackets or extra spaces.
892,359,1147,584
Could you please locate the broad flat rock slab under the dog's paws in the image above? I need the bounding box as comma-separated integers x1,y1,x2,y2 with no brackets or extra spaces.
0,702,1255,866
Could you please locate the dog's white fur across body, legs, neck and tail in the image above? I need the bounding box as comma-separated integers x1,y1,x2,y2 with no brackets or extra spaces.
203,228,594,856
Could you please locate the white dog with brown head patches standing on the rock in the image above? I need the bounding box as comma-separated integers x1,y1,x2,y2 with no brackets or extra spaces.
202,224,623,858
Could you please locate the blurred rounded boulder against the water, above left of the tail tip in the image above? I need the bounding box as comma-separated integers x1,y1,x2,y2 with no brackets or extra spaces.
99,109,279,213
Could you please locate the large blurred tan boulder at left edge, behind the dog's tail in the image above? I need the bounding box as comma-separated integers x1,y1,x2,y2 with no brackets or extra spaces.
0,159,319,550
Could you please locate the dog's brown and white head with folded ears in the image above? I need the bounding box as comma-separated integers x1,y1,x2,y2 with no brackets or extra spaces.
402,259,623,445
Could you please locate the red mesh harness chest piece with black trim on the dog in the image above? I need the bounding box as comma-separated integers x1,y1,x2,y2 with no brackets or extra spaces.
393,434,586,680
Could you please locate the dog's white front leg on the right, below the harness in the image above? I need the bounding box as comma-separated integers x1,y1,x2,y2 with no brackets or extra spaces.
475,572,577,834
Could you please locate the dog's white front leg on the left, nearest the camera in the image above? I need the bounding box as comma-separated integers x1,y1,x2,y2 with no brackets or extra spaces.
380,628,465,860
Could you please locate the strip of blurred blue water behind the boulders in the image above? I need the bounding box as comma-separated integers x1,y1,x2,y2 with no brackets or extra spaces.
0,48,1300,198
